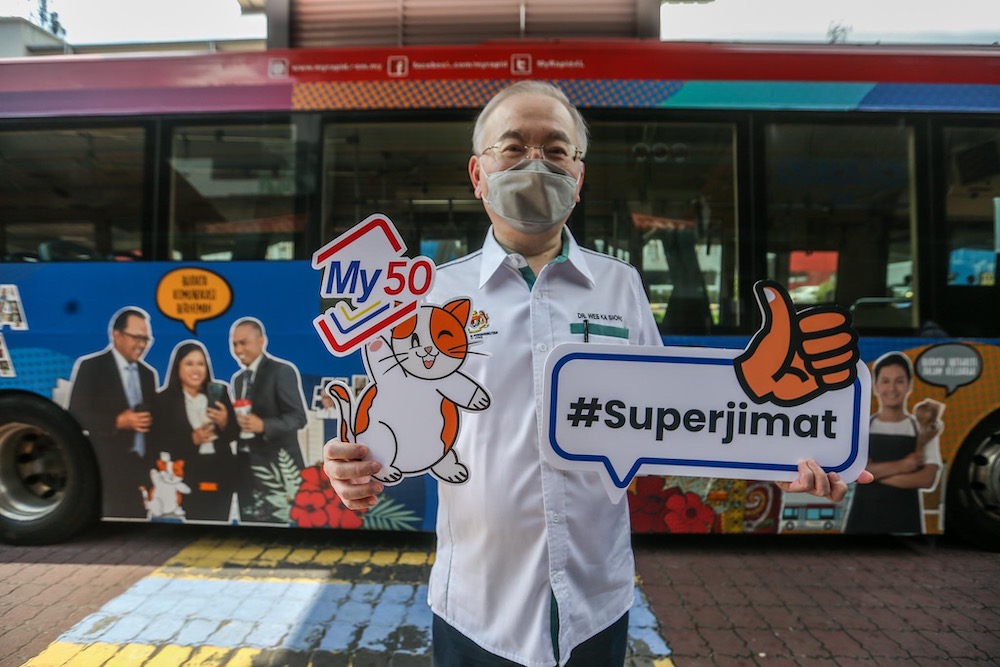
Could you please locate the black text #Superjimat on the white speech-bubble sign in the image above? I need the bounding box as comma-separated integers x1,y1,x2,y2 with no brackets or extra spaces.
566,396,837,445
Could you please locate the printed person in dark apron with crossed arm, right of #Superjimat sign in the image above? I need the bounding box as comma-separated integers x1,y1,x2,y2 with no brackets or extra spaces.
844,352,944,534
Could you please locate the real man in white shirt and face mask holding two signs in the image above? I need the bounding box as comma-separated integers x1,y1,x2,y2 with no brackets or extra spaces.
324,81,872,667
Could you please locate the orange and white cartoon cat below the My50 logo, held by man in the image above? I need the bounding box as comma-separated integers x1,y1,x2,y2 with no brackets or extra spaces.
326,298,492,485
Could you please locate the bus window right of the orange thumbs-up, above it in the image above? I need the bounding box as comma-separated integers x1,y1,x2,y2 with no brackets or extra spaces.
765,124,918,332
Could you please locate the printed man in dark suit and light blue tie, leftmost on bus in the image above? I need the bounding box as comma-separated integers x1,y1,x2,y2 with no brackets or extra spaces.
69,307,157,518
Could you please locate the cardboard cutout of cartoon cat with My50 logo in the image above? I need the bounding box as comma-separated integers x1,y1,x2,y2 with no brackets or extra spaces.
313,214,492,485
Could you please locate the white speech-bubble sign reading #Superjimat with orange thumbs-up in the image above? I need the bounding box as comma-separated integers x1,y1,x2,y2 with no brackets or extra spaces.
542,281,871,502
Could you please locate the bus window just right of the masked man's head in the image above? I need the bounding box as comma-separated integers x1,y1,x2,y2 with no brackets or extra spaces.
584,121,739,334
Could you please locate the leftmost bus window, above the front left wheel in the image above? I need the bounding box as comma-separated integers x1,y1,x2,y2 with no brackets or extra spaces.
0,127,145,262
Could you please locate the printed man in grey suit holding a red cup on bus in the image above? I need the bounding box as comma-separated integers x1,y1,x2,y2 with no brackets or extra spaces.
230,317,306,522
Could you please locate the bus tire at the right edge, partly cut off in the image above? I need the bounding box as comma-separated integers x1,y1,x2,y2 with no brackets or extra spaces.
945,414,1000,551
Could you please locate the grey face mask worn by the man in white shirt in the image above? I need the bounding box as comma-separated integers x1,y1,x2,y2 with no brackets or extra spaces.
486,160,577,234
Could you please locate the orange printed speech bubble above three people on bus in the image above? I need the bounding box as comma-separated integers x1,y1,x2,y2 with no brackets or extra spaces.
156,267,233,334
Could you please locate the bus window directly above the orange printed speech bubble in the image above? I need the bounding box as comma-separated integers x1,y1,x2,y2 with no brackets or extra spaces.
169,124,306,261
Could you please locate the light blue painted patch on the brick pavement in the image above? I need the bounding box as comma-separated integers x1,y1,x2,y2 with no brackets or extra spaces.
58,577,670,656
